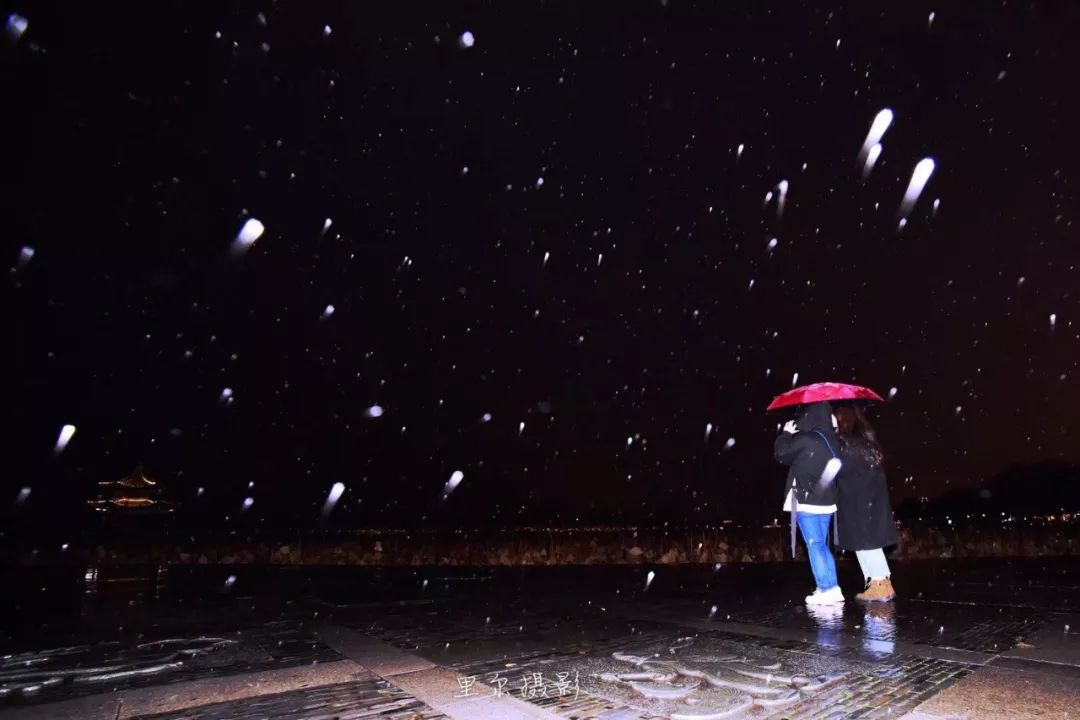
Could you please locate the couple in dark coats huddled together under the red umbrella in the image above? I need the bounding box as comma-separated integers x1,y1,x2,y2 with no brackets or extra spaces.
773,400,900,604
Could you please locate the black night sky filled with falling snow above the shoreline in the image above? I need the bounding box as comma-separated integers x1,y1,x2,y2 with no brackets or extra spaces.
10,0,1080,527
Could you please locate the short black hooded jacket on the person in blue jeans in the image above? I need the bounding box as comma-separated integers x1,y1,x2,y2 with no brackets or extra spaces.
772,403,839,505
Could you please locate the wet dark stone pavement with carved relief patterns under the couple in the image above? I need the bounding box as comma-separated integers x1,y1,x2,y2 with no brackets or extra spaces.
0,559,1080,720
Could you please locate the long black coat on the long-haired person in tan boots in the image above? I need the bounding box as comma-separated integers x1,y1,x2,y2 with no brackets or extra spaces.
836,448,900,551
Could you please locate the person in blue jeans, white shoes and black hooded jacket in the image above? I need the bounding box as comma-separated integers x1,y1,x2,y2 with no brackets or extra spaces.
773,403,843,604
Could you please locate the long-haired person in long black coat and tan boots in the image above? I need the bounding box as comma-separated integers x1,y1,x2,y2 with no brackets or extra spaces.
835,404,900,601
